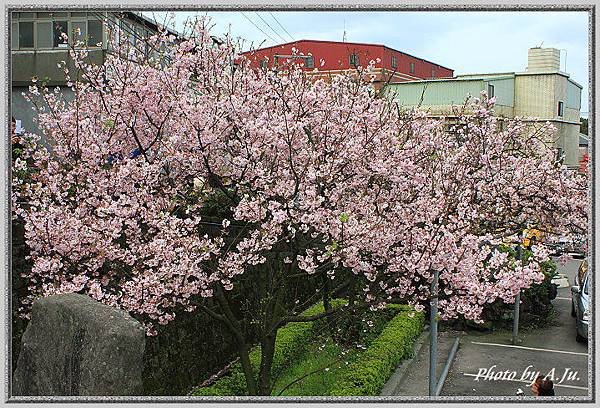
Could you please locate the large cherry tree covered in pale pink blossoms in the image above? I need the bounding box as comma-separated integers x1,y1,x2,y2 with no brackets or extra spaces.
13,17,587,395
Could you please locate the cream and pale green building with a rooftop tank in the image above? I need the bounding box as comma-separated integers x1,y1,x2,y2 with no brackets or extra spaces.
386,48,582,167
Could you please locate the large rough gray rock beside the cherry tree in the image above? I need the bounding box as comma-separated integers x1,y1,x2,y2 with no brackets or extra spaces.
12,294,145,396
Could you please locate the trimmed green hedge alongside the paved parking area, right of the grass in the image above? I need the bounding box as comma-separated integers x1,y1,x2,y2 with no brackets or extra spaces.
330,306,424,396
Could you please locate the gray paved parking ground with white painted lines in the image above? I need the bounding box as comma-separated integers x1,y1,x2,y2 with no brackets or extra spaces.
394,260,588,396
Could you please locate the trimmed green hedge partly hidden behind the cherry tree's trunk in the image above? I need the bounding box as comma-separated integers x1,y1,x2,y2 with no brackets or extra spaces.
192,299,346,396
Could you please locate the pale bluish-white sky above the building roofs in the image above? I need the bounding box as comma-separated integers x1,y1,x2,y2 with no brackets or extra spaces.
148,11,589,117
